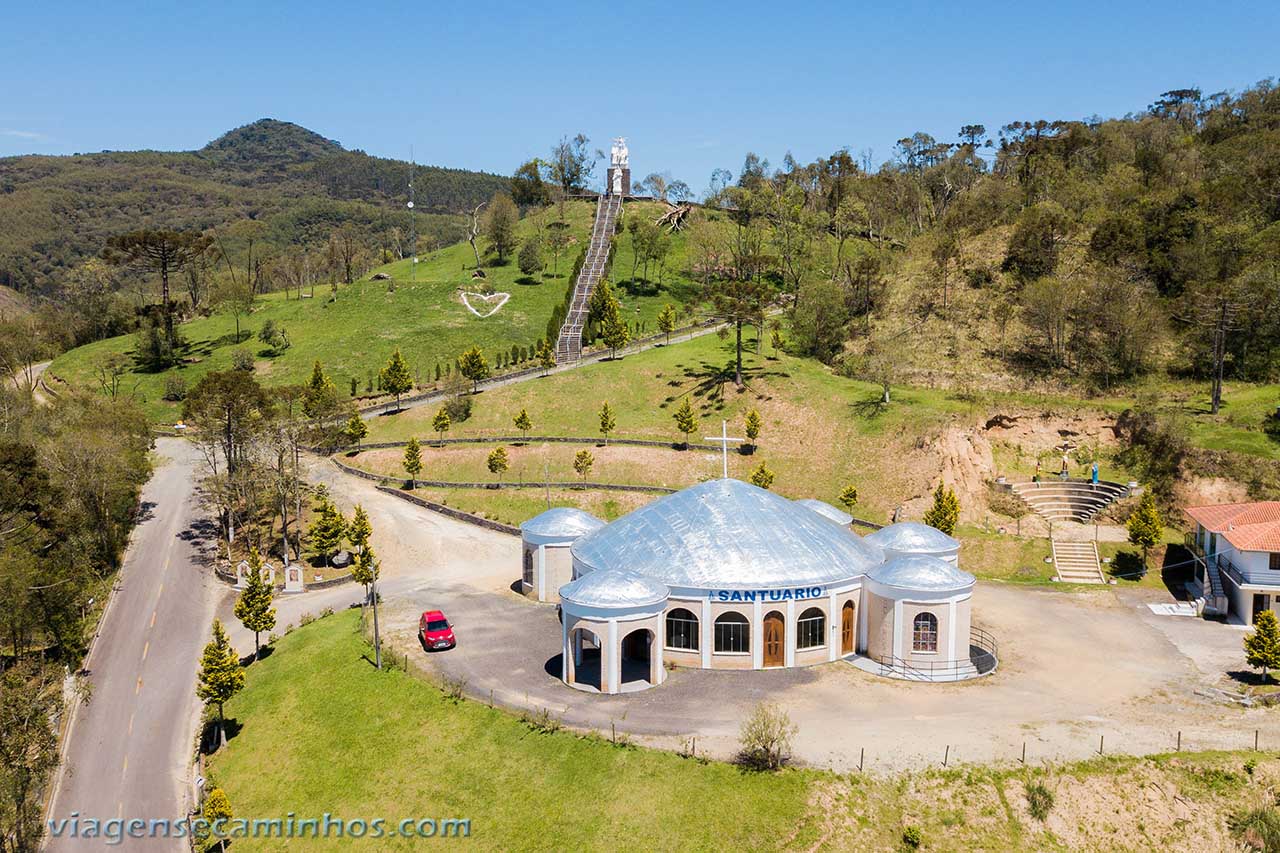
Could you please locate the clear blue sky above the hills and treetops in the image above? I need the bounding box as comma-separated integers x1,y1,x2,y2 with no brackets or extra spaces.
0,0,1280,190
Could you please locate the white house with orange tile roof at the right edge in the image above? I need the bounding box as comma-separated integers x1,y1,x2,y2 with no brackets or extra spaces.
1185,501,1280,624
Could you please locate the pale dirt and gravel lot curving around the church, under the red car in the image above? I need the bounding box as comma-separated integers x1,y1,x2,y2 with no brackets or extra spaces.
312,460,1280,771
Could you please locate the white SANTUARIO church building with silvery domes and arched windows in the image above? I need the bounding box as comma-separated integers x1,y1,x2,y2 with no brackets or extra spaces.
522,478,995,693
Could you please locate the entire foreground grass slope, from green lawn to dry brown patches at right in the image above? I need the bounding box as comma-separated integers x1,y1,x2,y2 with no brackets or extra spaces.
207,611,1280,852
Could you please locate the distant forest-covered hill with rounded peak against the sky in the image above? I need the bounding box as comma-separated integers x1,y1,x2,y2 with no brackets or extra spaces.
0,119,508,295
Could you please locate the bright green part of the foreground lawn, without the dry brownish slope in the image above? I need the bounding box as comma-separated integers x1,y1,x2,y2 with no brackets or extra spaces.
210,612,822,850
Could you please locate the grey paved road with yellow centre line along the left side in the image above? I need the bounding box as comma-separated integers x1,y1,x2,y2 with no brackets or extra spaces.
47,438,214,850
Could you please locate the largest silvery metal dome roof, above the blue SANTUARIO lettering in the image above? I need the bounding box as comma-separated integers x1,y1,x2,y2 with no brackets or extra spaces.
571,479,884,589
